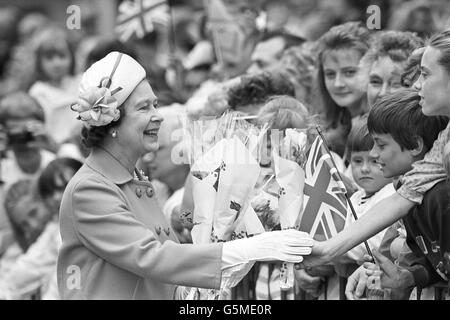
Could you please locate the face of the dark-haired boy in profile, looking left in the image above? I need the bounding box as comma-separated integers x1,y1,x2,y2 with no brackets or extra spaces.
370,133,415,178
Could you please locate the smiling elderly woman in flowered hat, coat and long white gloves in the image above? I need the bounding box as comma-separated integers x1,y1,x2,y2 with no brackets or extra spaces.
58,52,312,299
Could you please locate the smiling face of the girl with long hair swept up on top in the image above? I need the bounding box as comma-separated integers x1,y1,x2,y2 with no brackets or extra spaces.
323,49,368,108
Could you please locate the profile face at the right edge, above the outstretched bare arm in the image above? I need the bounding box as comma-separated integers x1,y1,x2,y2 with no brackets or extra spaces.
413,47,450,116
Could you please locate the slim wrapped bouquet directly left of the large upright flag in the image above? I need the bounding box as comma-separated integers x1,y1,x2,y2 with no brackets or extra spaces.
272,129,308,290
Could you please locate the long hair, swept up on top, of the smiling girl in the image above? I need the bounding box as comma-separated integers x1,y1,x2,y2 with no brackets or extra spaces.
317,22,371,128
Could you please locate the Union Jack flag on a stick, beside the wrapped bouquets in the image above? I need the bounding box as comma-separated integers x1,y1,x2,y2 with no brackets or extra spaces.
300,137,348,240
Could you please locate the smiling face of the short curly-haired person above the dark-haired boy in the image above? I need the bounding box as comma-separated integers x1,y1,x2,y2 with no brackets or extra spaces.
367,57,403,107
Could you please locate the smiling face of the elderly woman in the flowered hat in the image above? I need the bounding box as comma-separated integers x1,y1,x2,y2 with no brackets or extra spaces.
113,80,163,158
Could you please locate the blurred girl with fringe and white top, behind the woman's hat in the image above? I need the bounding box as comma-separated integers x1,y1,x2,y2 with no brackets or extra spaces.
29,27,79,143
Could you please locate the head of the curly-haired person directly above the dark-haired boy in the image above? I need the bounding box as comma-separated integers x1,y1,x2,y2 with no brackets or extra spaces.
362,31,423,108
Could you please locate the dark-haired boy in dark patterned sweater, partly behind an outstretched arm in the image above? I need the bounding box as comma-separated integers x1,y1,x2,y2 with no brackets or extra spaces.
346,89,448,299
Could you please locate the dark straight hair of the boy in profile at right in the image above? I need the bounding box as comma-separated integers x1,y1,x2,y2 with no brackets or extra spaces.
367,88,448,153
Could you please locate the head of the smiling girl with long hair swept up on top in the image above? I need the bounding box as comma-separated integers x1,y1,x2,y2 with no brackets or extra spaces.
317,22,371,156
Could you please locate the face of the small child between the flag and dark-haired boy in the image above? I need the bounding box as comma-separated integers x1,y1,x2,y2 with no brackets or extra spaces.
350,151,392,194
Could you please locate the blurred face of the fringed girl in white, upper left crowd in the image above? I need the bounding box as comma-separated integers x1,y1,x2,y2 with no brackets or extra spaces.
41,46,72,82
